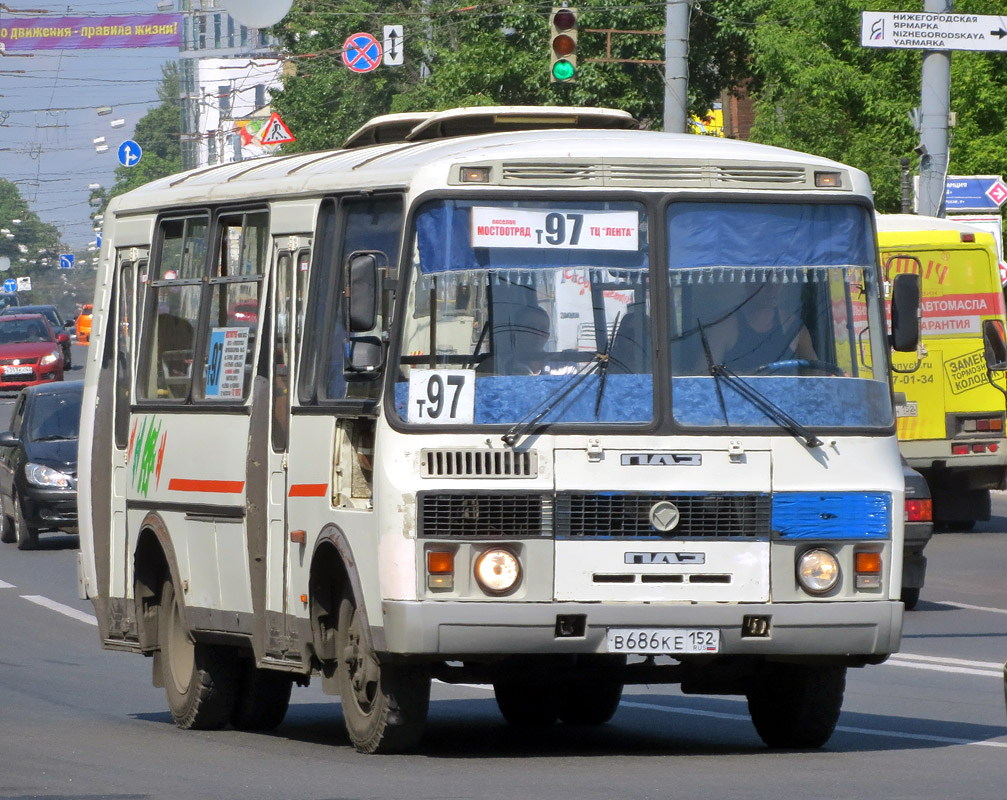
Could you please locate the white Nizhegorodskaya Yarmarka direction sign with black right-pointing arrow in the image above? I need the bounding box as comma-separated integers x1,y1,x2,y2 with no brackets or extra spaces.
860,11,1007,51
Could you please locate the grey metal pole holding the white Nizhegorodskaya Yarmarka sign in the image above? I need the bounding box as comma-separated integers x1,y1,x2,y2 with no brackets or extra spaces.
916,0,954,217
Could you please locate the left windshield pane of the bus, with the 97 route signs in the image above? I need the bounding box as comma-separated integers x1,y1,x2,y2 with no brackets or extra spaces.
395,198,654,424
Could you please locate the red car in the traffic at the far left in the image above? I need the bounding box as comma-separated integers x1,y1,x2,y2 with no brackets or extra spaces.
0,314,68,391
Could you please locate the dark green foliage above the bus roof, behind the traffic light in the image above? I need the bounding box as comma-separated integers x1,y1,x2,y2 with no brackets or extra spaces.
272,0,765,152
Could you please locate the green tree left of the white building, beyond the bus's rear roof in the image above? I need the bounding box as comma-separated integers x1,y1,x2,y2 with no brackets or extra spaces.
108,61,182,199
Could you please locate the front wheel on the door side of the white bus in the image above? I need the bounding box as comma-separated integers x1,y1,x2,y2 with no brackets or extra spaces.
336,589,430,754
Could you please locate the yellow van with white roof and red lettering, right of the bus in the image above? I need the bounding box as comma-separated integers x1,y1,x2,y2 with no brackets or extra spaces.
877,214,1007,530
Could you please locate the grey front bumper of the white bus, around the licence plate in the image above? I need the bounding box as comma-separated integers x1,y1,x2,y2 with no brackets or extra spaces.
372,601,904,657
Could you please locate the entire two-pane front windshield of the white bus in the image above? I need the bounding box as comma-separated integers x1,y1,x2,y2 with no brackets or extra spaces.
395,198,892,428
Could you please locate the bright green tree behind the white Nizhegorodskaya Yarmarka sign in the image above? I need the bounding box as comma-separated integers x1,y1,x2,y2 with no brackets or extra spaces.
752,0,1007,212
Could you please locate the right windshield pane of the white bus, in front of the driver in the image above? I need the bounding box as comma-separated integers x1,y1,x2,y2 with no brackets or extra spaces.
668,203,892,427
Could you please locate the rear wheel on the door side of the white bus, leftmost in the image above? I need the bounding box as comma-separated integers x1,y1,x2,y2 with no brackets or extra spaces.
157,577,238,730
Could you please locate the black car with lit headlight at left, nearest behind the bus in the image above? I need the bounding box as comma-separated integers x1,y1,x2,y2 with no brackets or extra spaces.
0,381,84,550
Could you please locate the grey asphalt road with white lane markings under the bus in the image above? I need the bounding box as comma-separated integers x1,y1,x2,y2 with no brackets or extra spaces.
0,344,1007,800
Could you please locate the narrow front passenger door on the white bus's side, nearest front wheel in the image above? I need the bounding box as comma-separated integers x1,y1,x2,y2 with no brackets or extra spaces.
265,237,310,657
